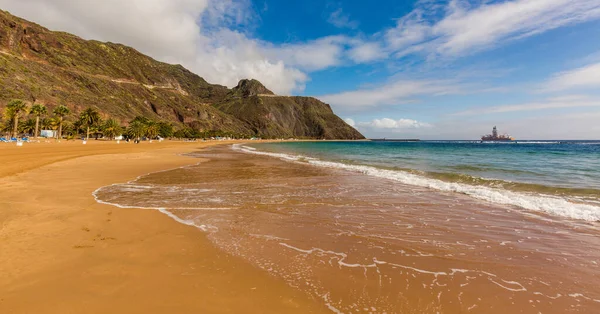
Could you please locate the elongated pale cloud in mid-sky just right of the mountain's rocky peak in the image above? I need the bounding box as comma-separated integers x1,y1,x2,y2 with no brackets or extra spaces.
319,80,462,111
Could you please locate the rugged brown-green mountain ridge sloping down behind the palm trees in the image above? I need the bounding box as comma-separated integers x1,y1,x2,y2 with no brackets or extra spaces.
0,10,363,139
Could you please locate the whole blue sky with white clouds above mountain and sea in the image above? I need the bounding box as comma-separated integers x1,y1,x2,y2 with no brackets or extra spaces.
0,0,600,139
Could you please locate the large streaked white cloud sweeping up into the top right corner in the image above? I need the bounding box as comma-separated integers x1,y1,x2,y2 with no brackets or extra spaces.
385,0,600,57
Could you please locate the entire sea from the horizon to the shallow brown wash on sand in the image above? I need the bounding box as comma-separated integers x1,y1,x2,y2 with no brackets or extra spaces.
94,141,600,313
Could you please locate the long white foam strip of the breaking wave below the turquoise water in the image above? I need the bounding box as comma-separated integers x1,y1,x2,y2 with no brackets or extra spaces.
233,145,600,221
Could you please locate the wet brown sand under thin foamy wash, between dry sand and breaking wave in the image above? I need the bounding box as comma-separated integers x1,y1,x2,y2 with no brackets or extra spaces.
97,147,600,313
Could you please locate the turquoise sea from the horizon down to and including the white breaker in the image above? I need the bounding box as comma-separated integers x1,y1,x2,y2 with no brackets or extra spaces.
249,141,600,220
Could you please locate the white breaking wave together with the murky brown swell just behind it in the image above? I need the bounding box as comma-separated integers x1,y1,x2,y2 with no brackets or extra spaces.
244,144,600,222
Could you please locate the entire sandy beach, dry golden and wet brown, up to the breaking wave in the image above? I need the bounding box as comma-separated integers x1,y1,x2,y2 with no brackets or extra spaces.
0,141,600,313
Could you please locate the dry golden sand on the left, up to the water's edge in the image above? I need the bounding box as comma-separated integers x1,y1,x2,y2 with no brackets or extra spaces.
0,141,327,313
